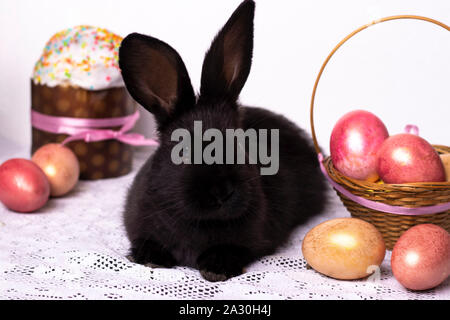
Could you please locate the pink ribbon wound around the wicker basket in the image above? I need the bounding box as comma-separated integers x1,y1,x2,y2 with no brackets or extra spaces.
318,125,450,216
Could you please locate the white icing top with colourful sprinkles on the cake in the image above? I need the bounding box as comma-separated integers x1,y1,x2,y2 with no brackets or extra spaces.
33,25,123,90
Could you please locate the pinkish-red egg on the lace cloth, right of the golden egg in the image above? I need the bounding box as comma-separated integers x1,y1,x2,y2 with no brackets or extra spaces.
391,224,450,290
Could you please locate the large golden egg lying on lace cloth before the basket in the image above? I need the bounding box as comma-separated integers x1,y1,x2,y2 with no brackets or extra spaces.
302,218,386,280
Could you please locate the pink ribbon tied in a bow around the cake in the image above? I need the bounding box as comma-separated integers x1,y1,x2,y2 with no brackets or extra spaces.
31,110,159,146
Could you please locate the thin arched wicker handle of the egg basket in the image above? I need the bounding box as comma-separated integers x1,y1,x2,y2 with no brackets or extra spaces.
310,15,450,154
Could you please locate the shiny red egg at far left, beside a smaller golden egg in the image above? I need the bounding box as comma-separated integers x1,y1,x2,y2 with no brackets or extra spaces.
0,159,50,212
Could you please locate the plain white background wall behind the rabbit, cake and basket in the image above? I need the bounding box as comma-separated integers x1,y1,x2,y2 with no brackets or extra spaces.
0,0,450,153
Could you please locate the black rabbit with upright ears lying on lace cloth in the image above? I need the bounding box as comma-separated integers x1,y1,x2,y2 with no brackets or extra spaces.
119,0,326,281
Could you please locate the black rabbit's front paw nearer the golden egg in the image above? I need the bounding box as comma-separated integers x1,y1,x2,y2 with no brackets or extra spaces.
197,245,250,282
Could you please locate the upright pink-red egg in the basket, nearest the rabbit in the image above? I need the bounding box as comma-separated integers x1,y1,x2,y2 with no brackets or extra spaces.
330,110,389,182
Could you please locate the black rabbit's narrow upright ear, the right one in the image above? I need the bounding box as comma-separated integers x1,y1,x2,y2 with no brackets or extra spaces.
200,0,255,101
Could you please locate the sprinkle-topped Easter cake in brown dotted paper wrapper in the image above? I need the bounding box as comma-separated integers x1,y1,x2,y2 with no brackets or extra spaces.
31,25,136,179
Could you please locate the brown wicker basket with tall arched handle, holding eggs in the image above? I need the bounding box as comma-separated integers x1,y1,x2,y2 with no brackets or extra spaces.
310,15,450,250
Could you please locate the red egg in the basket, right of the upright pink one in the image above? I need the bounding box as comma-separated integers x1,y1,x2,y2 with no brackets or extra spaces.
377,133,445,183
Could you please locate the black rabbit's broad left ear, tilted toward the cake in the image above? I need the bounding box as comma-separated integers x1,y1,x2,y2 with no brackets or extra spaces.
119,33,195,127
